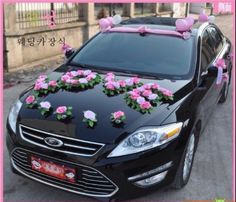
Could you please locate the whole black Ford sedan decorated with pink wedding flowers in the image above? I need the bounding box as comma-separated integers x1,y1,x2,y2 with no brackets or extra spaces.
7,18,232,199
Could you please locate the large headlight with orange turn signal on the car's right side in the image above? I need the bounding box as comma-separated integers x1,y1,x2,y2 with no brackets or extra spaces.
108,123,183,157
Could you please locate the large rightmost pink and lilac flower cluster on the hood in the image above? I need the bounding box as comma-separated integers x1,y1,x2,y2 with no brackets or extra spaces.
125,83,173,113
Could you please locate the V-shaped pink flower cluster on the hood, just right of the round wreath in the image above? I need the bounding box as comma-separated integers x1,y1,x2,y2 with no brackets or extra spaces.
103,72,142,96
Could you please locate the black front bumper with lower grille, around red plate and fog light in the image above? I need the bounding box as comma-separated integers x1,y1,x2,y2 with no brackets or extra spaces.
7,124,184,200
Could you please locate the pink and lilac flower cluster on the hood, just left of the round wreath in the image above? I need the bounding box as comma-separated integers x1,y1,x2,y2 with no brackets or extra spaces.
34,75,58,96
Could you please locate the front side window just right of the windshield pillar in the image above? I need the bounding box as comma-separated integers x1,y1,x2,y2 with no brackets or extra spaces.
201,31,215,72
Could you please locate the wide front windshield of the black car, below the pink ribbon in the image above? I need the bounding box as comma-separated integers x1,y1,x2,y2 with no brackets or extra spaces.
71,33,193,79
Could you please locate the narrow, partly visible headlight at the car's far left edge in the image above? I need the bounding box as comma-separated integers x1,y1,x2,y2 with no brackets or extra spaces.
8,100,22,133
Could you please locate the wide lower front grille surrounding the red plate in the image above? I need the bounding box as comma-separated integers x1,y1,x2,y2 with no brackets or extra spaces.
11,148,118,197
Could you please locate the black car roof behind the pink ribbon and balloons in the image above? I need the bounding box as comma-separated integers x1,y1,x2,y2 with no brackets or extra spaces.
119,16,205,36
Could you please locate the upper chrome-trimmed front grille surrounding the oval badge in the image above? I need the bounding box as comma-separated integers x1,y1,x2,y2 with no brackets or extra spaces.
20,125,104,156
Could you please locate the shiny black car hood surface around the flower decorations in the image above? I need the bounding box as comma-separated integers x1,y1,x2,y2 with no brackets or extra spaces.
18,67,191,144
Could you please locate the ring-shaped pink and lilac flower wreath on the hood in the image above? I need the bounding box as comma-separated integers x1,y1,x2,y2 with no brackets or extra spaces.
59,70,101,90
